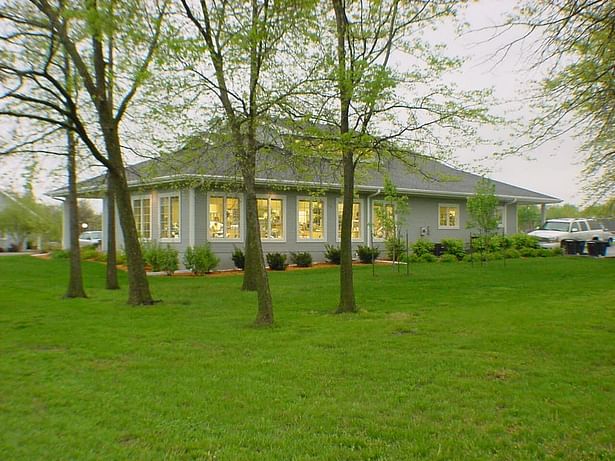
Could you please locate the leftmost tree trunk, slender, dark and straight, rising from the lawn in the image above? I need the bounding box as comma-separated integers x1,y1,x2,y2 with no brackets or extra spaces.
64,127,87,298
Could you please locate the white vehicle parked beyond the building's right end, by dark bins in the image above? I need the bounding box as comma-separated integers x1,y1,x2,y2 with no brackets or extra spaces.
529,218,613,248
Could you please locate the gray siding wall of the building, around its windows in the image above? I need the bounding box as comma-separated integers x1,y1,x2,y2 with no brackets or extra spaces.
103,189,517,269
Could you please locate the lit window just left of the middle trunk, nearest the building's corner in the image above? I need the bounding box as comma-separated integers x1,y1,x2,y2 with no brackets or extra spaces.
207,194,241,240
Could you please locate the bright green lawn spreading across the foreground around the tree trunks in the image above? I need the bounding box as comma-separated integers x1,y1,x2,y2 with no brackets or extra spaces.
0,257,615,460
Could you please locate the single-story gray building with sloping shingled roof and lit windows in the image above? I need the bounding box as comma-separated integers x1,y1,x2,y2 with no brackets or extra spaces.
50,142,560,268
